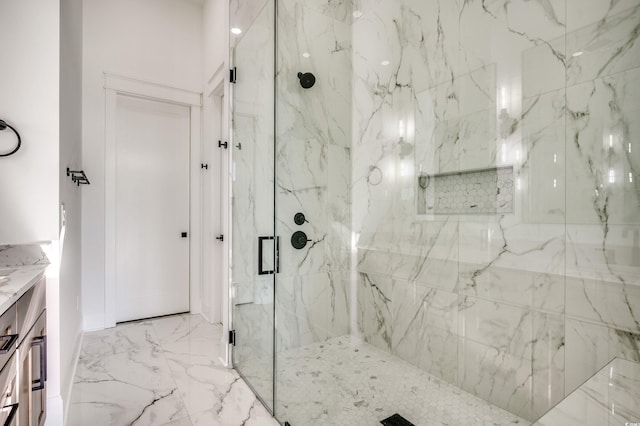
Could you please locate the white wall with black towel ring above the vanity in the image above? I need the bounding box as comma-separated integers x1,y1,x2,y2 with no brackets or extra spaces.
0,0,60,244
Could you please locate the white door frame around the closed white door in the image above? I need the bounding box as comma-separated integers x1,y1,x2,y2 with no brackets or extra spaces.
104,73,202,328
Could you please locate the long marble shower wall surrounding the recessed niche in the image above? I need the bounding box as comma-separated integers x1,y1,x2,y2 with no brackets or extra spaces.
350,0,640,420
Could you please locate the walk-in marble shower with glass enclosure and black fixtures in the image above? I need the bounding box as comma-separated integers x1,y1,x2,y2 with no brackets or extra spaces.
230,0,640,426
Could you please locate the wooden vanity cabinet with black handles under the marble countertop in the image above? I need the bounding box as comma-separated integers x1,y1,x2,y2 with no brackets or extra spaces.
0,278,47,426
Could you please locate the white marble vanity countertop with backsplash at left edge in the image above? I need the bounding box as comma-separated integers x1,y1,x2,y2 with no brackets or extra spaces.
0,244,49,315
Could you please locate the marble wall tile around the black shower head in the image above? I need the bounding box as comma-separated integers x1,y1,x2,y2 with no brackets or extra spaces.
276,1,351,150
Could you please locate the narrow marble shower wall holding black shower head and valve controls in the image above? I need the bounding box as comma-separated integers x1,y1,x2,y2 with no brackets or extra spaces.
276,0,351,351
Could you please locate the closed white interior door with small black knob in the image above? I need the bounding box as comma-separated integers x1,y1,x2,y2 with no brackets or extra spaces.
115,95,190,322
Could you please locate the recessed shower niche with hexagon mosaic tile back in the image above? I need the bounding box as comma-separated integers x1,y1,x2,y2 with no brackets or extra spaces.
416,166,513,215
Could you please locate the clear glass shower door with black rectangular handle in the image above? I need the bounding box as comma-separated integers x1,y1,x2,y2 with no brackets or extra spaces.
229,1,277,410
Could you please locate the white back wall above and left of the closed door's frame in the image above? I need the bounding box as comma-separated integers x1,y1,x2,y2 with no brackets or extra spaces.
82,0,203,330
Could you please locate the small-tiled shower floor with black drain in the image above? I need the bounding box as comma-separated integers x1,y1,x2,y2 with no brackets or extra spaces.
243,336,530,426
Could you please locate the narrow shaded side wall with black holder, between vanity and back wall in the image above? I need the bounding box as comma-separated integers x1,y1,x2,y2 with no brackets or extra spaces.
57,0,85,424
